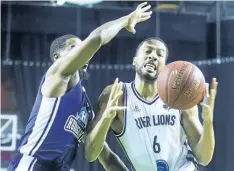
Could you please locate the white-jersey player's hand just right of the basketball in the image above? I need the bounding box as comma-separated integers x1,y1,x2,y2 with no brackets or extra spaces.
201,78,218,122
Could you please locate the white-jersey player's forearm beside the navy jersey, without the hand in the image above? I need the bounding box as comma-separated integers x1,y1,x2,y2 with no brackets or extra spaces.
85,117,112,162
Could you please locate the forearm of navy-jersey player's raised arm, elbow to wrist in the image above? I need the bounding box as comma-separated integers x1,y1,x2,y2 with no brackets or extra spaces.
91,16,129,45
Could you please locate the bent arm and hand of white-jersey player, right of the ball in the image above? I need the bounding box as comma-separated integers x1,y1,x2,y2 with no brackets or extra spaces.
182,78,218,165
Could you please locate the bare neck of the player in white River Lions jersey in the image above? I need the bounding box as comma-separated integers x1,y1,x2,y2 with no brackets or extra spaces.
135,76,158,100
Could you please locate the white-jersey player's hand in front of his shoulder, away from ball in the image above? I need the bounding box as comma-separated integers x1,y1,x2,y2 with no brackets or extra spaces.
104,78,127,119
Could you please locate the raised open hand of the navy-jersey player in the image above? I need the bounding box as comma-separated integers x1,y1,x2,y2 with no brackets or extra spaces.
126,2,152,34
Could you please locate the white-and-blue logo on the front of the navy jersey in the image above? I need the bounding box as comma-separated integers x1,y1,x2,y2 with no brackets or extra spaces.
64,107,89,143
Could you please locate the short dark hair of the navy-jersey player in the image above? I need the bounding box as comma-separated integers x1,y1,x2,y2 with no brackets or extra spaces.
50,34,78,61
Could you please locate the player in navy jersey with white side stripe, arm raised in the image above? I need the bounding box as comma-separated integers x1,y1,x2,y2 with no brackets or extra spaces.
8,3,152,171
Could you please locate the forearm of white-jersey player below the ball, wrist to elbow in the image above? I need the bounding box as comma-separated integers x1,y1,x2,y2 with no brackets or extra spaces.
195,121,215,166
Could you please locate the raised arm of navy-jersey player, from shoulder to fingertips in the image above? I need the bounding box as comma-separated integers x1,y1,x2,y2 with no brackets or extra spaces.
41,3,152,97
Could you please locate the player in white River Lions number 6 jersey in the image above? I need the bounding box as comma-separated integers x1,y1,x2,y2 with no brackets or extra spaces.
87,38,218,171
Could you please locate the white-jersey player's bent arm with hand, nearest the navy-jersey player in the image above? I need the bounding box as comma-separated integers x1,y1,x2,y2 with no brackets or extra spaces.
84,79,125,162
